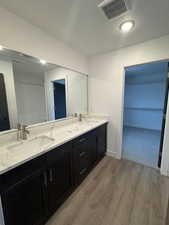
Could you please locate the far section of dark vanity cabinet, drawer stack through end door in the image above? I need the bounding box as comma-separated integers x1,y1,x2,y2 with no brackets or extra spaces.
73,124,107,185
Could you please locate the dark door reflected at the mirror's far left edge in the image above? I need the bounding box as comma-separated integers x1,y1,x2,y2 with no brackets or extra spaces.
0,74,10,131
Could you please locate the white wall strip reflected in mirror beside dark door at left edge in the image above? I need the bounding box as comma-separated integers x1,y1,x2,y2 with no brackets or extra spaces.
0,60,18,129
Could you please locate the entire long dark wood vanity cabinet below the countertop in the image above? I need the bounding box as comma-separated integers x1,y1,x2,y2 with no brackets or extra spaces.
0,124,107,225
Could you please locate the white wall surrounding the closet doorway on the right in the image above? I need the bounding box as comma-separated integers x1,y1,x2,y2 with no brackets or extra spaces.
89,36,169,175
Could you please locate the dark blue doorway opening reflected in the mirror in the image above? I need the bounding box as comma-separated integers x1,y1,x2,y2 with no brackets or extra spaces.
53,79,66,120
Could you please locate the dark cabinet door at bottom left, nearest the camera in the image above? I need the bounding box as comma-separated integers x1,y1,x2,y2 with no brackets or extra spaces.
1,171,45,225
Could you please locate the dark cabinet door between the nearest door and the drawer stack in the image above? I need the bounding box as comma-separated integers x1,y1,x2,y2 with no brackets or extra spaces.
48,144,72,214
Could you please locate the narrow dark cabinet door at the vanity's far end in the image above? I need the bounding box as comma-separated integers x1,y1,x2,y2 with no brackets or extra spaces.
97,125,107,159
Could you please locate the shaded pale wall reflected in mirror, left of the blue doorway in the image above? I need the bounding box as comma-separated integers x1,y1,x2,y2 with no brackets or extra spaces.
14,72,47,125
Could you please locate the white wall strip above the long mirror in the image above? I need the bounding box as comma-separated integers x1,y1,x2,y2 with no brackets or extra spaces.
0,7,88,74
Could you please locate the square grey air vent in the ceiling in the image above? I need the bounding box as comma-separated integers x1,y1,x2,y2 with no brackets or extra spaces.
98,0,129,20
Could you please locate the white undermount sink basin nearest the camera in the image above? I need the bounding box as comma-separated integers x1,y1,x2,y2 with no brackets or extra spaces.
8,135,54,156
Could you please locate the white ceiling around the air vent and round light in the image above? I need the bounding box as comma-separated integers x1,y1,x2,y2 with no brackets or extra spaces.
0,0,169,55
